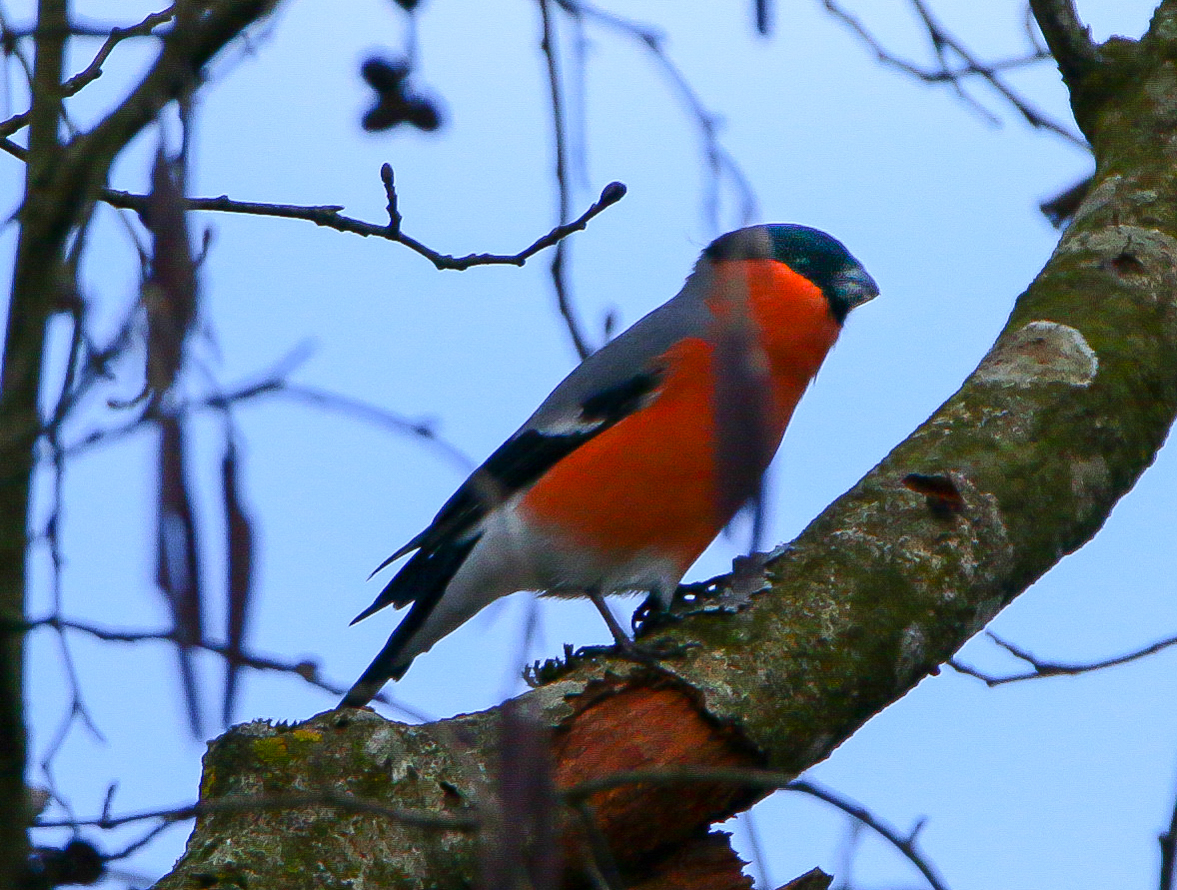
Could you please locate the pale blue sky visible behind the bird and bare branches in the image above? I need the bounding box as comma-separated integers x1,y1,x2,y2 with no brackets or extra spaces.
0,0,1177,890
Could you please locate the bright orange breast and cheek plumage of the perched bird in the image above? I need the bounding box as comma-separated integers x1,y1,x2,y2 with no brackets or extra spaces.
520,260,838,572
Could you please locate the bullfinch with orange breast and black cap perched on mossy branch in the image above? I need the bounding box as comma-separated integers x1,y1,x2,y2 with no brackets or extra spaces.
340,224,879,708
